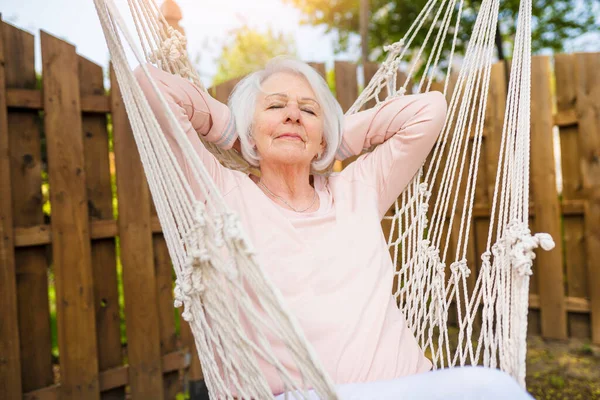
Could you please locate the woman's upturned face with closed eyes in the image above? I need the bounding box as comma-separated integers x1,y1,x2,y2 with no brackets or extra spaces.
252,72,325,166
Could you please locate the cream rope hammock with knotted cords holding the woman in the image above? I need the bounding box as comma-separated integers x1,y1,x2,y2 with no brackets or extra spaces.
94,0,554,399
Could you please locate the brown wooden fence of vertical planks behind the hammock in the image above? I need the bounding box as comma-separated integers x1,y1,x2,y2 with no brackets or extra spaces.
0,21,600,399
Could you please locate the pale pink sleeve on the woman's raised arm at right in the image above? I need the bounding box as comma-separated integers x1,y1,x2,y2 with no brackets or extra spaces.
337,92,447,217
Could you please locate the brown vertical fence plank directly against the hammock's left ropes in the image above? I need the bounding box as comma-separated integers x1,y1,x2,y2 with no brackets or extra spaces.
111,66,163,399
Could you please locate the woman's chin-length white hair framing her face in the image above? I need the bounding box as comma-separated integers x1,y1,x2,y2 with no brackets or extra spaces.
229,57,344,172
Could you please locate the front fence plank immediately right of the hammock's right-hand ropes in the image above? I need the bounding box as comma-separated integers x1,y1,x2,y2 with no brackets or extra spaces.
531,56,567,339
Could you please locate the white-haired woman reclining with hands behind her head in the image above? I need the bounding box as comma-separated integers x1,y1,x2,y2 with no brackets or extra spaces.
135,58,523,399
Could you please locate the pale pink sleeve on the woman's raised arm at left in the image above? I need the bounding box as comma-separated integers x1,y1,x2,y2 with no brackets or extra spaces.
133,64,238,196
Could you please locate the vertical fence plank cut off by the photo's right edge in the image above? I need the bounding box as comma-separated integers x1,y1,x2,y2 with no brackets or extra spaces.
575,53,600,344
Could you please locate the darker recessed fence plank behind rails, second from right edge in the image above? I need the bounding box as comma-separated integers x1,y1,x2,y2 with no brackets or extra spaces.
554,54,591,338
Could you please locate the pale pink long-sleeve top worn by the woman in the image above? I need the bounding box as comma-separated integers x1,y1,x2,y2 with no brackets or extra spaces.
135,66,446,394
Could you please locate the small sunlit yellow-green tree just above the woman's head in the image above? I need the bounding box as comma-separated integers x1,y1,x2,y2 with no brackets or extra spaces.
213,25,296,86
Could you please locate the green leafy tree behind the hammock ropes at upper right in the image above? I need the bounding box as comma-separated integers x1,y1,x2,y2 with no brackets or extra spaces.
285,0,600,60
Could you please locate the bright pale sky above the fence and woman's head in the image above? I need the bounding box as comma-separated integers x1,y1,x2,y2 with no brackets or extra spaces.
0,0,359,84
